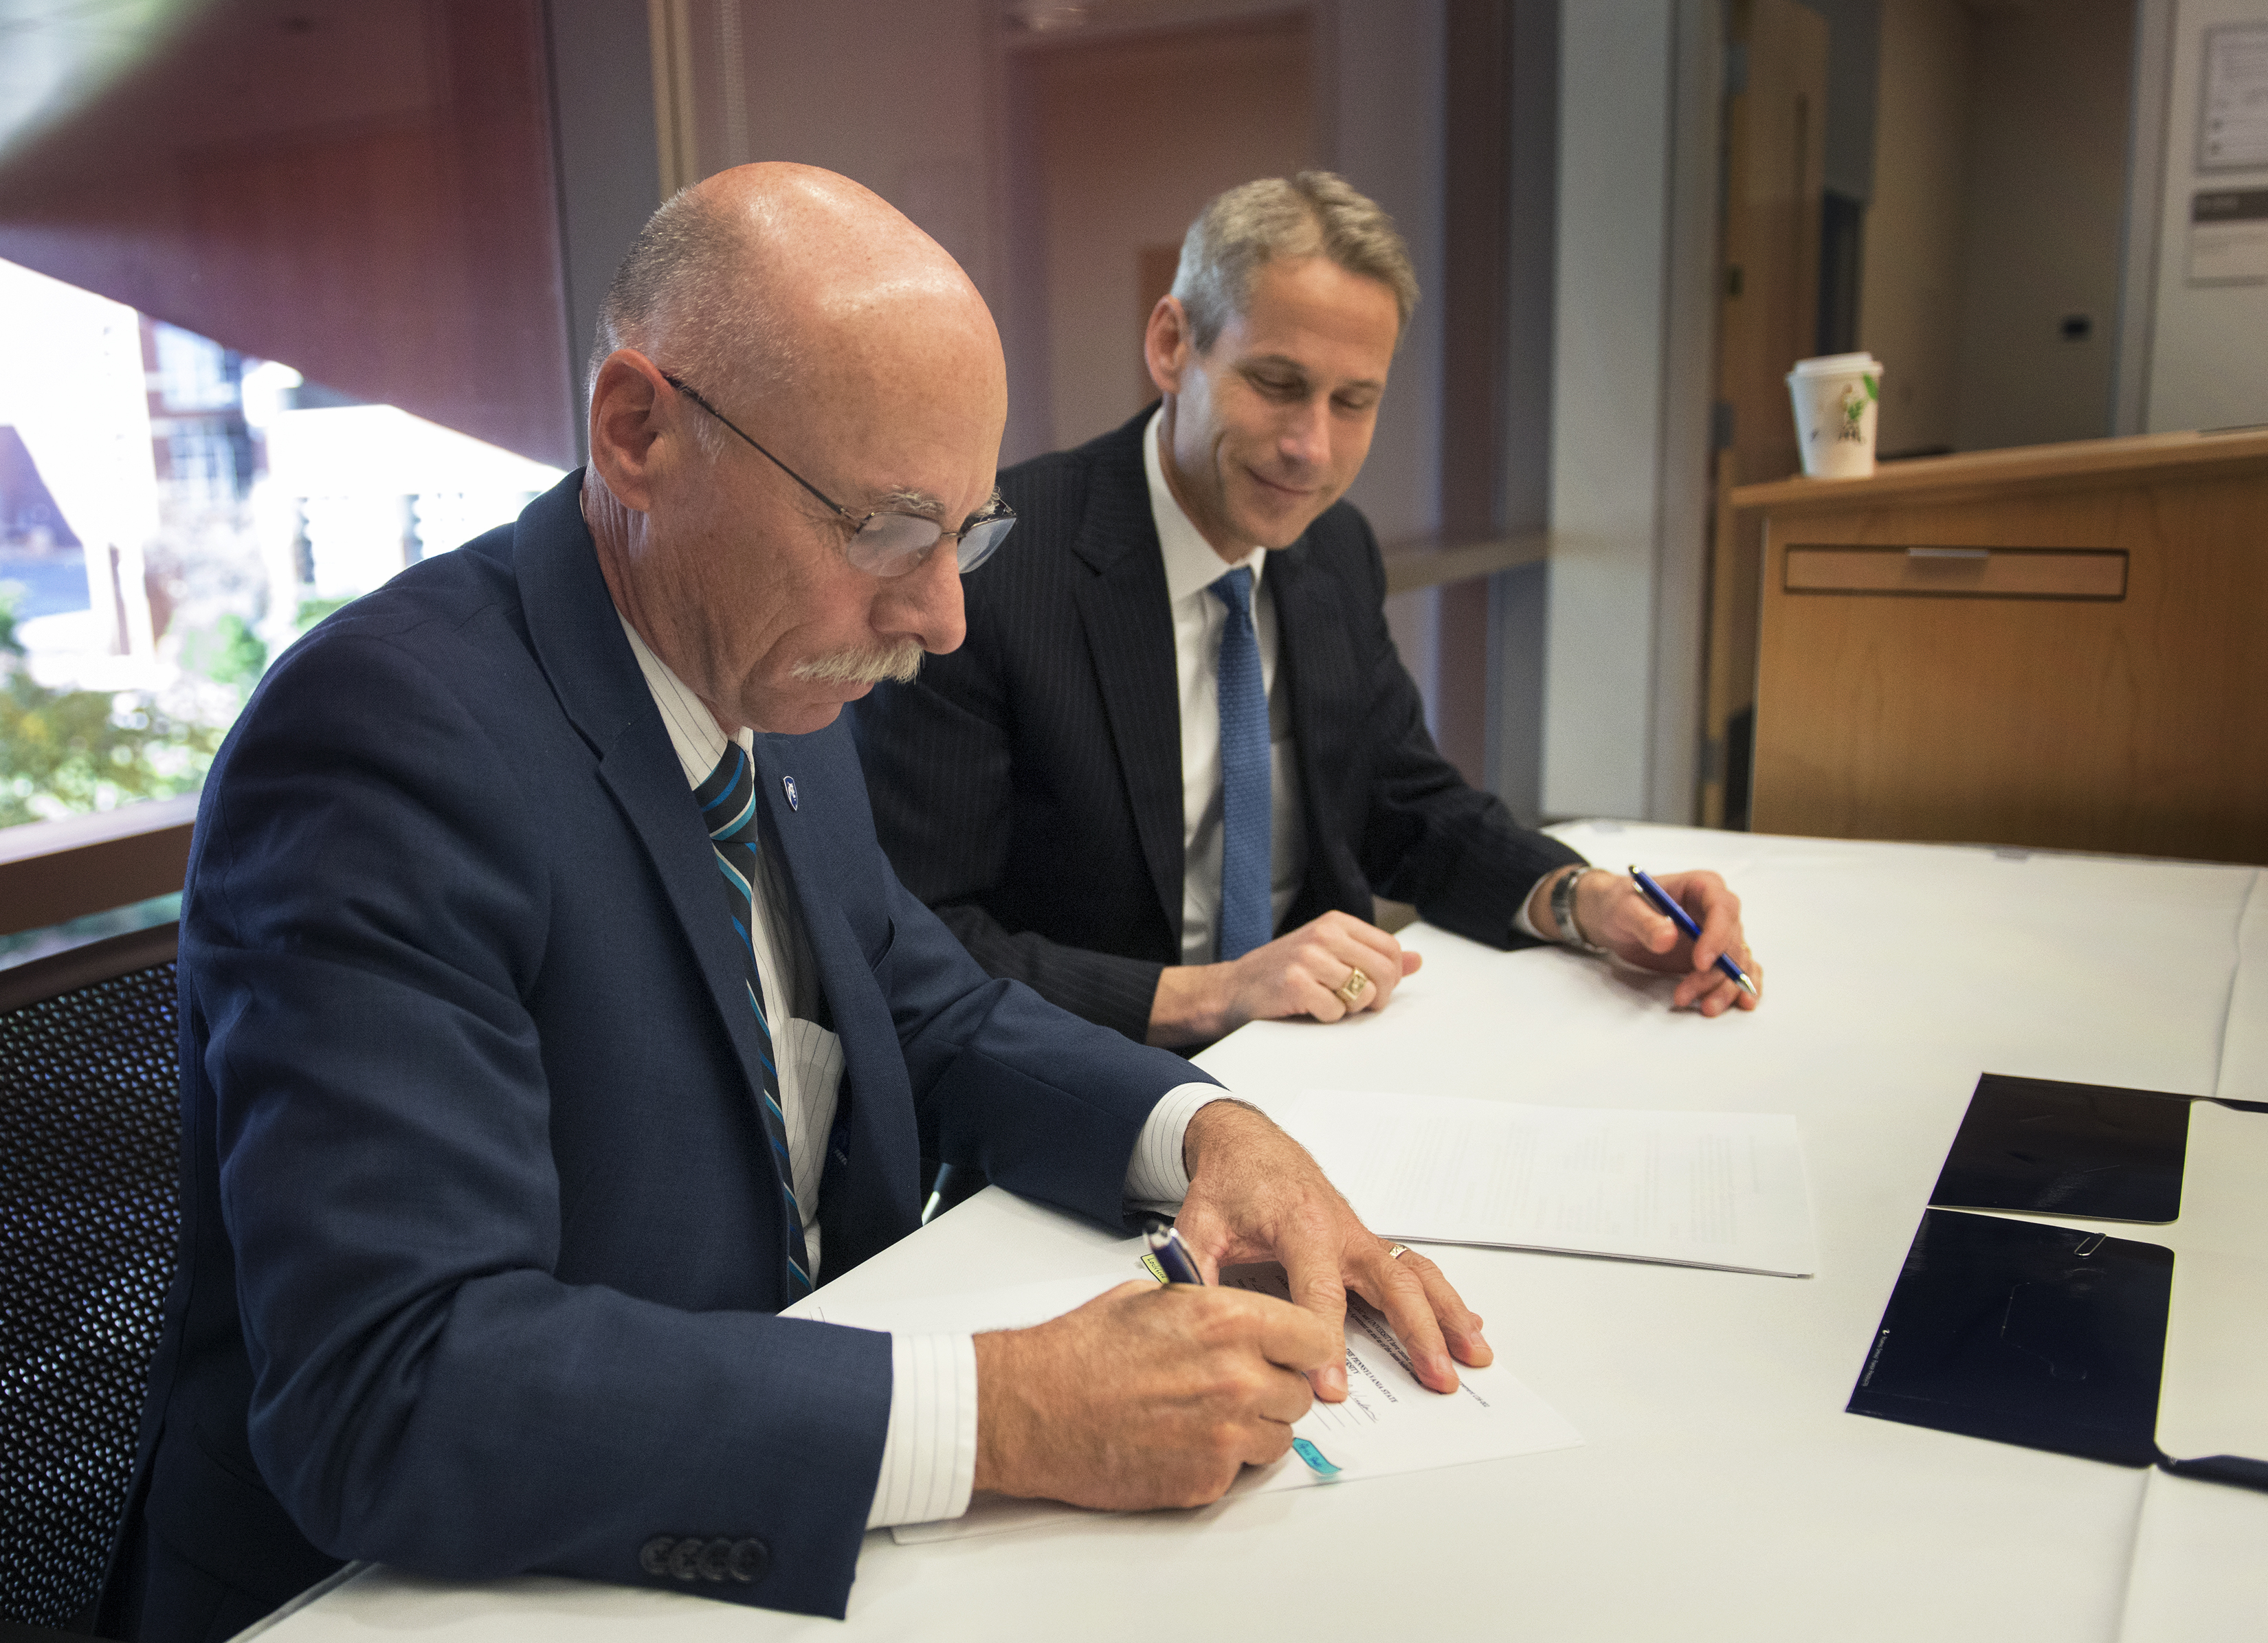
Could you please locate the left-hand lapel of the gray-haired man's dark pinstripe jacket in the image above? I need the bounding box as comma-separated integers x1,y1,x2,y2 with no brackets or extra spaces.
1073,417,1181,934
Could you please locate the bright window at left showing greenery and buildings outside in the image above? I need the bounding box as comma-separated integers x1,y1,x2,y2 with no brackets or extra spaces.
0,263,560,827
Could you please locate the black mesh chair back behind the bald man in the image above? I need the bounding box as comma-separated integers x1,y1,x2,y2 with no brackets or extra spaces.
0,925,181,1634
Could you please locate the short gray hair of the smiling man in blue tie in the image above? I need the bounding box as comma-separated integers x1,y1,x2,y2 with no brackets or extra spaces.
1172,172,1418,353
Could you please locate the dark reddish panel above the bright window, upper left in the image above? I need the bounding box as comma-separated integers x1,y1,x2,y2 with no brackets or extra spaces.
0,0,576,467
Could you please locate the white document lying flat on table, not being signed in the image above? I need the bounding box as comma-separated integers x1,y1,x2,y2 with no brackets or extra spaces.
1265,1090,1819,1278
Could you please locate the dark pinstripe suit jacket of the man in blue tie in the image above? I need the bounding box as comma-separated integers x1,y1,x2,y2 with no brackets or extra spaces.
853,410,1581,1038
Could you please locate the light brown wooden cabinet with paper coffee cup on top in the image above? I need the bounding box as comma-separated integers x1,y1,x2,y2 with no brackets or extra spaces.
1731,433,2268,864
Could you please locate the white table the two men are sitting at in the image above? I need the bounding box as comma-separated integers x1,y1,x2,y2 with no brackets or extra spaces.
248,823,2268,1643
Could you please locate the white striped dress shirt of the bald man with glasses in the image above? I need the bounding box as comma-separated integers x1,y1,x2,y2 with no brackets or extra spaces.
617,612,1227,1530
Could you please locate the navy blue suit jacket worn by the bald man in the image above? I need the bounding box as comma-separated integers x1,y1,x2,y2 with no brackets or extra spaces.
110,476,1202,1636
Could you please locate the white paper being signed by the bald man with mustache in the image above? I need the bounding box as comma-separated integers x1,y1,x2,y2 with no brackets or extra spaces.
787,1253,1583,1545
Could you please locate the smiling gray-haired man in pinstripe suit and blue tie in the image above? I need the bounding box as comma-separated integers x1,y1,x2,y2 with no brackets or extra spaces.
853,172,1760,1047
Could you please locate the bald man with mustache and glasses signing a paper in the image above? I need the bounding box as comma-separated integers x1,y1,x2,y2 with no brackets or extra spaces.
102,166,1490,1638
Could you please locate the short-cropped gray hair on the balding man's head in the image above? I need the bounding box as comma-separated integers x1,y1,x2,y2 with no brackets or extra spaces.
583,188,796,456
